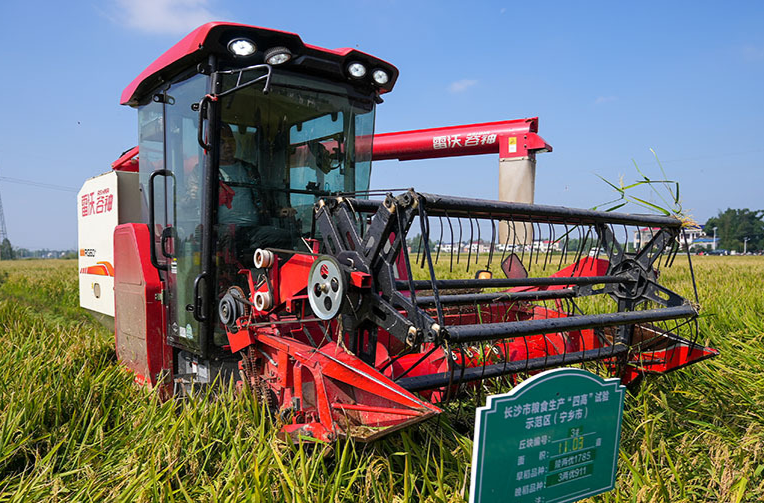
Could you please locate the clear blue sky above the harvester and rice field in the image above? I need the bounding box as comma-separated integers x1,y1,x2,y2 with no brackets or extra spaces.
0,0,764,248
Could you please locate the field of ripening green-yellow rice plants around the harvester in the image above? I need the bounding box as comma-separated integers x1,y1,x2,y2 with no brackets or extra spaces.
0,257,764,502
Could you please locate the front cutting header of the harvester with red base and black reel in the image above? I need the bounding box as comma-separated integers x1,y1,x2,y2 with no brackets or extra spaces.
215,190,716,440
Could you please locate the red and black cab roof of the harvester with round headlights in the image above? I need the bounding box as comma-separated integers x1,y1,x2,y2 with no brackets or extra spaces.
120,22,398,106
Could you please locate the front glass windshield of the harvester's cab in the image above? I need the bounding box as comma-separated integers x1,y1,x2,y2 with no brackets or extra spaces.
218,72,374,242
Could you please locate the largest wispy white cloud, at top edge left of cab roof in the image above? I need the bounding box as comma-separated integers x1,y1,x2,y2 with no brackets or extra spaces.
117,0,218,35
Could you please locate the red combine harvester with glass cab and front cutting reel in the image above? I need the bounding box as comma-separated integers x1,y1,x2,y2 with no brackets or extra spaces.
78,23,717,440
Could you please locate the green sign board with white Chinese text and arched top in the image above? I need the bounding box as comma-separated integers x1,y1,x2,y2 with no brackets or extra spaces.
470,368,625,503
